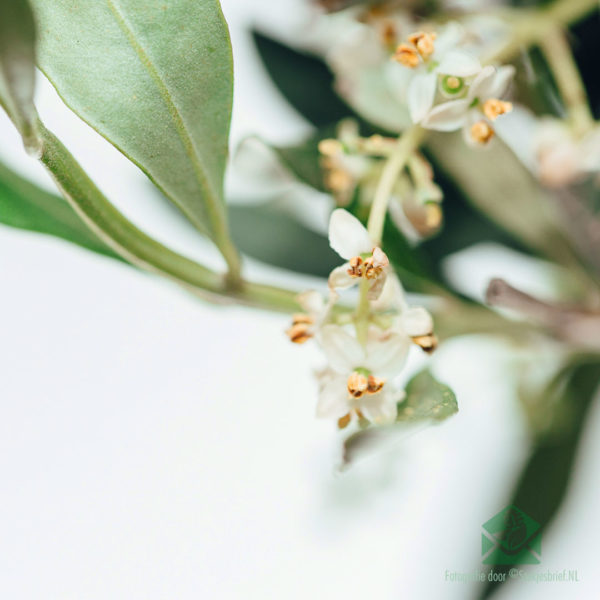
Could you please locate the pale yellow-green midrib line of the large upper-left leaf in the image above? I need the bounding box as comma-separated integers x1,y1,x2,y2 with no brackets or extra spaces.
106,0,222,235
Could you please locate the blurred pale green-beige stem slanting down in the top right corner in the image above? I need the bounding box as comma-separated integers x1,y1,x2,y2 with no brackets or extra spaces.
539,27,594,136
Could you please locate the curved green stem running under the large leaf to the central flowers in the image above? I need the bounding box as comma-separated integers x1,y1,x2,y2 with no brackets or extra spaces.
39,124,298,312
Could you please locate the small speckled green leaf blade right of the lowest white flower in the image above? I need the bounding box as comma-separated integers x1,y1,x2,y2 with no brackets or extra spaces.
397,369,458,422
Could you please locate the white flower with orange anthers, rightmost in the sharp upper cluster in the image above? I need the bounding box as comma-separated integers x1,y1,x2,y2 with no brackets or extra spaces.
421,66,514,143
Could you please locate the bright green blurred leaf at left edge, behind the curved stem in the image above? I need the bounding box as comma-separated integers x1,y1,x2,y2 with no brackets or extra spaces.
0,164,122,260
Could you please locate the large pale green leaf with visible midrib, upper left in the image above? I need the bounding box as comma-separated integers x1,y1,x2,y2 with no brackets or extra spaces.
32,0,233,244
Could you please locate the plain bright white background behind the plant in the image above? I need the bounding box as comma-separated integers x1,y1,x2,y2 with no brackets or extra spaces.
0,0,600,600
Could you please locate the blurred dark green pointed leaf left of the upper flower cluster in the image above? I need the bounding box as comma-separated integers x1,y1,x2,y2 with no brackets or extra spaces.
253,31,352,127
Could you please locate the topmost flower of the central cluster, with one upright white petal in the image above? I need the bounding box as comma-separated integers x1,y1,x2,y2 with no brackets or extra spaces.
329,208,389,299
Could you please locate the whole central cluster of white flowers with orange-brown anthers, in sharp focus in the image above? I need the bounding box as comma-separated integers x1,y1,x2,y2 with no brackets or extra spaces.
287,209,437,428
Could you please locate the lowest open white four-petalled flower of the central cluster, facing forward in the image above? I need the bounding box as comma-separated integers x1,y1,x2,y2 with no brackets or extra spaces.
317,325,410,427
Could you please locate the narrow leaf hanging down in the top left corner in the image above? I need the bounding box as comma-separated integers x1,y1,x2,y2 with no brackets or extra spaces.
0,0,39,152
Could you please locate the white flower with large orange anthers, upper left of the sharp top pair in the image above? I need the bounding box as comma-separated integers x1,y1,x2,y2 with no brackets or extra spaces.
390,23,481,123
